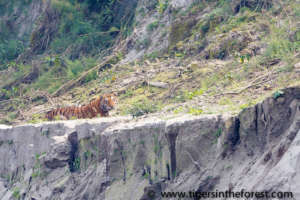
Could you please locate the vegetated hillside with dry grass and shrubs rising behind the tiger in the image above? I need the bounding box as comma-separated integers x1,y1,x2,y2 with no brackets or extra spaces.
0,0,300,124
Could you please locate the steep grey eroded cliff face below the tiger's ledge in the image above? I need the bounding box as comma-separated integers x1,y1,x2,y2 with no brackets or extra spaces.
0,88,300,200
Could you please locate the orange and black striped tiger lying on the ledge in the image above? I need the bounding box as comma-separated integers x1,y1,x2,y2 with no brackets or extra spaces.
45,94,116,120
